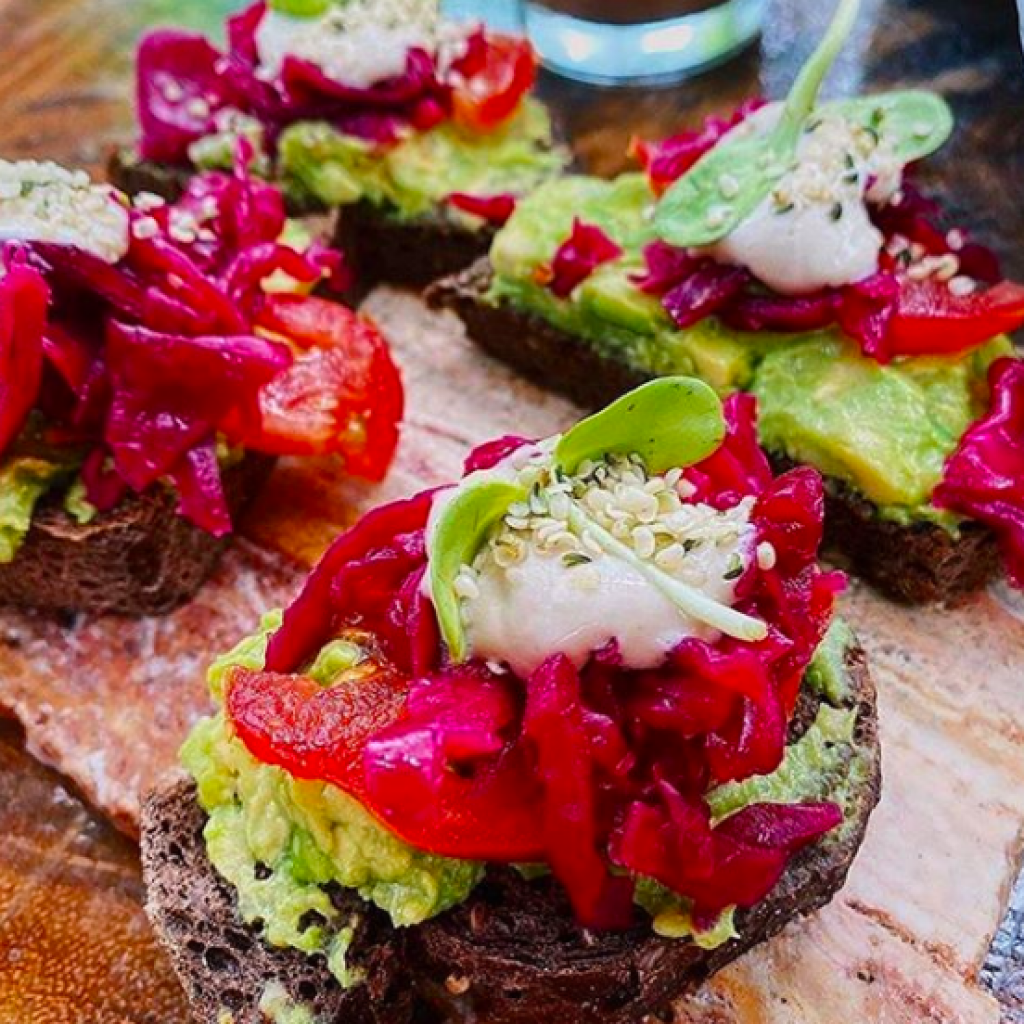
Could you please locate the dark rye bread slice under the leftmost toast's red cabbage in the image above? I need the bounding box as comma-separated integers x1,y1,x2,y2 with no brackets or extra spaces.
0,454,274,615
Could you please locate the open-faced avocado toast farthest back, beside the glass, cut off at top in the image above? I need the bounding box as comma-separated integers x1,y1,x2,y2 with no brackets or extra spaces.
112,0,567,285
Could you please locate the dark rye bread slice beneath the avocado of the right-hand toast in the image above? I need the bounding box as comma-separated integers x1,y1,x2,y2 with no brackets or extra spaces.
426,259,1000,604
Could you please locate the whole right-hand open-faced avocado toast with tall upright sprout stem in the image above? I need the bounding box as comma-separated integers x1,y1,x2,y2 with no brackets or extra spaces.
432,3,1024,601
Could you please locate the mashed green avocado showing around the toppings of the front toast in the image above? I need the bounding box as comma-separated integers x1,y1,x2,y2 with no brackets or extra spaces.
181,612,870,987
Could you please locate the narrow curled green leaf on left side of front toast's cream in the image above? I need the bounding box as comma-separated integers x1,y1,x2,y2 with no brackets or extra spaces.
430,479,528,662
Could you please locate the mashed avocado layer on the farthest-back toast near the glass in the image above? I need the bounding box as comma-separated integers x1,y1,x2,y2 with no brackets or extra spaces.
191,98,568,227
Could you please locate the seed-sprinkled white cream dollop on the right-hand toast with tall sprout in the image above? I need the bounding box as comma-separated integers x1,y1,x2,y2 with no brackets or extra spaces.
708,103,903,295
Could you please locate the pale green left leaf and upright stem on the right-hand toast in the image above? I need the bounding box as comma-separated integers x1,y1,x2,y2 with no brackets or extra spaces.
654,0,860,247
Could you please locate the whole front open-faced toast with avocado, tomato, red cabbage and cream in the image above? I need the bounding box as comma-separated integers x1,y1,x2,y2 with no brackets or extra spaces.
142,377,879,1024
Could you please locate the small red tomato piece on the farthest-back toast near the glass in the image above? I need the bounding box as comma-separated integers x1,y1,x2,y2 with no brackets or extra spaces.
452,36,537,132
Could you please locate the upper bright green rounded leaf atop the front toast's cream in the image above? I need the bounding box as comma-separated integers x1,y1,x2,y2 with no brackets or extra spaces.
554,377,725,474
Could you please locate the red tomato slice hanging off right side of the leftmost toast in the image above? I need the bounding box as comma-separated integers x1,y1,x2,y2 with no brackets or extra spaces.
237,295,404,480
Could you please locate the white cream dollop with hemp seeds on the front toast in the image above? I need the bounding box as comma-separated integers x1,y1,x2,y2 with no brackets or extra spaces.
427,446,759,677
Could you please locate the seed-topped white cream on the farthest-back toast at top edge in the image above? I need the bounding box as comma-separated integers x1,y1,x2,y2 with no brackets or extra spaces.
256,0,448,88
